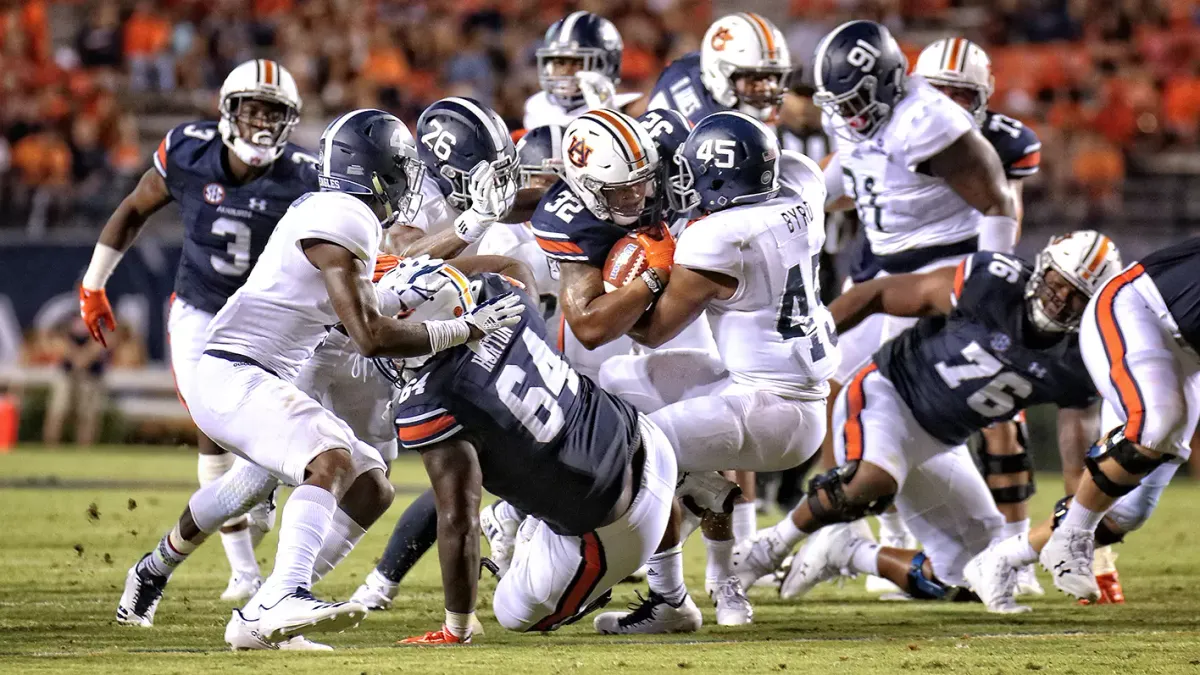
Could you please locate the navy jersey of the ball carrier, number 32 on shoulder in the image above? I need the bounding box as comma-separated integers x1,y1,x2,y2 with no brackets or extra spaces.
529,180,629,268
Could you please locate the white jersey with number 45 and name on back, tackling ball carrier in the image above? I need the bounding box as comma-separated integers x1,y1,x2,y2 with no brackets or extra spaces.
674,163,839,399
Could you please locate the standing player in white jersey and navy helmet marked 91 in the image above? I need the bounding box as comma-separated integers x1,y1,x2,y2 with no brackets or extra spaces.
812,20,1018,578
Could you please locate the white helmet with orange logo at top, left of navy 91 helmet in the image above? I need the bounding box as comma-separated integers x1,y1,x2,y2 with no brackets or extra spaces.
700,12,792,120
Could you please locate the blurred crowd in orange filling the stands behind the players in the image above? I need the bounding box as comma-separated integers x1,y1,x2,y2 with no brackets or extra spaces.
0,0,1200,235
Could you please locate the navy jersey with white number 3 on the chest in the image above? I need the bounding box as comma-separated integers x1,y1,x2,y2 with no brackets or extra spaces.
154,121,317,313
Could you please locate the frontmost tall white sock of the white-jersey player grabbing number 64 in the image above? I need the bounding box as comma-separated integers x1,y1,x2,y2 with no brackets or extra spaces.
259,485,337,597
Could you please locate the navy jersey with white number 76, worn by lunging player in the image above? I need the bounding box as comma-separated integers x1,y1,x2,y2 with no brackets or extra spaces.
875,252,1097,446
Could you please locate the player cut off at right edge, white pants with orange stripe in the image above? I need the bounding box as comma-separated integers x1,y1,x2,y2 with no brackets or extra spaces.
972,239,1200,602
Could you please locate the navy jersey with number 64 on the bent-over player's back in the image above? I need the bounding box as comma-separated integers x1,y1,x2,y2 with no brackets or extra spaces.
396,274,641,536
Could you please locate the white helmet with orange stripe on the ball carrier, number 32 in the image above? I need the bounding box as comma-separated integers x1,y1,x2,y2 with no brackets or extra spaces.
562,108,665,227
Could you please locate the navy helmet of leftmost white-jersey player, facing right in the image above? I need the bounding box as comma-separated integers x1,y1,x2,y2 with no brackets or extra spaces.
317,108,425,227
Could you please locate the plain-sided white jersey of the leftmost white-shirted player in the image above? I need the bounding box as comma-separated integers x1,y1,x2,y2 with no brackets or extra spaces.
206,192,383,381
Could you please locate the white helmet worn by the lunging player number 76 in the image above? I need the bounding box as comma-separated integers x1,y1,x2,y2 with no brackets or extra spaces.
1025,229,1122,333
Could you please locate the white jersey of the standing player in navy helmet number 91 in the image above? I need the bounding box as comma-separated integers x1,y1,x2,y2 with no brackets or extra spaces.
826,77,983,256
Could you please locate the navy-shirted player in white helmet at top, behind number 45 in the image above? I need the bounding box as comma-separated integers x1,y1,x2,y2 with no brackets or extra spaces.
649,12,792,124
